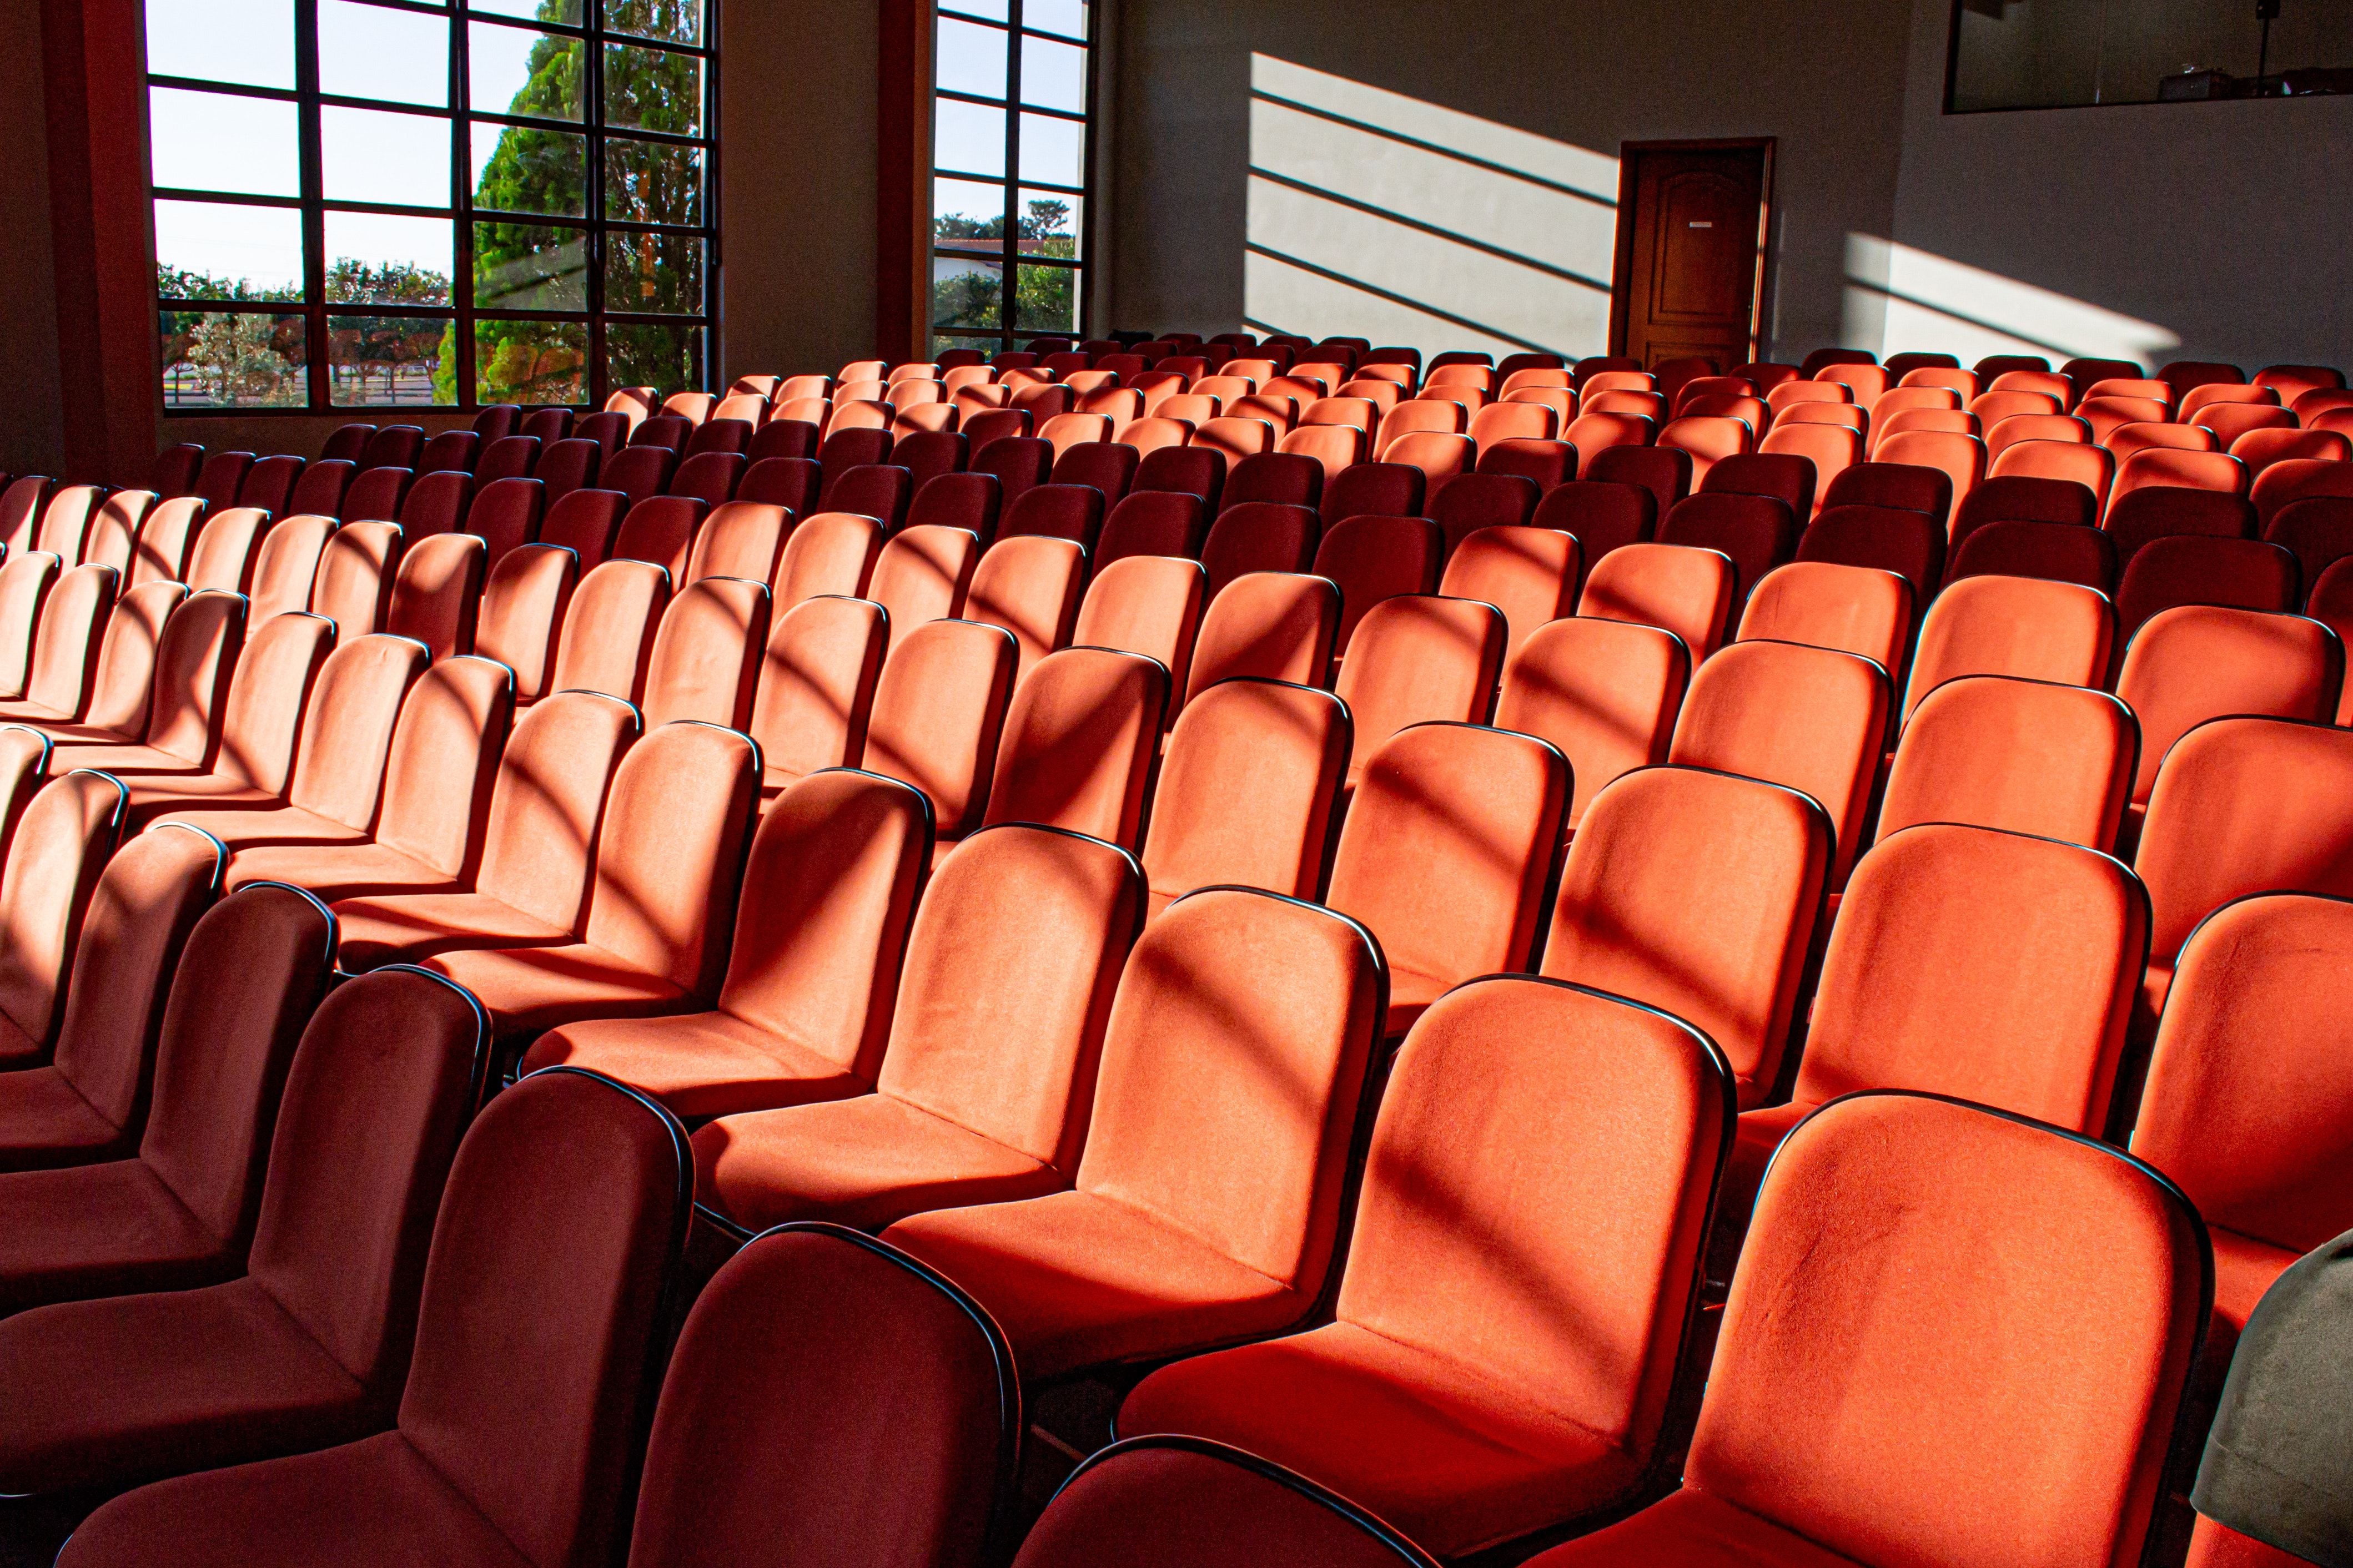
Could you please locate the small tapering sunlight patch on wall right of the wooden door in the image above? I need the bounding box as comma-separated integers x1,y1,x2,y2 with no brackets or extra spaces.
1840,233,2181,364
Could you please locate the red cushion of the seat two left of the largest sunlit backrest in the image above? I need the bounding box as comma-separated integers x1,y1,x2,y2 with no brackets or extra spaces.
884,1194,1311,1378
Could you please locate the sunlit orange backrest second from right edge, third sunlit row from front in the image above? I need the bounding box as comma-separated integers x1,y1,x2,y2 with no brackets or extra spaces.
1878,675,2141,851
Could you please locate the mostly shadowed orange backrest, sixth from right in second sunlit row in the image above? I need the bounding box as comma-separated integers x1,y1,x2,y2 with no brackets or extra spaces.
981,649,1169,849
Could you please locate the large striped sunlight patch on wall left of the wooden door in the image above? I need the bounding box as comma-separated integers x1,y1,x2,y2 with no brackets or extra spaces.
1243,54,1619,357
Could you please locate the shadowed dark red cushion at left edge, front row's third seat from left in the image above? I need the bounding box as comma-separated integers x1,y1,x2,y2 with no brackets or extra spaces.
0,1159,245,1314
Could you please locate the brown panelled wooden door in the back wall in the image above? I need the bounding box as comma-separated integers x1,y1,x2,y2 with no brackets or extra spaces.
1610,141,1772,371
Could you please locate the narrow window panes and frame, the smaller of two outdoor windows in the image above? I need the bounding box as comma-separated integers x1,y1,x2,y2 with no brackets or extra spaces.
932,0,1094,355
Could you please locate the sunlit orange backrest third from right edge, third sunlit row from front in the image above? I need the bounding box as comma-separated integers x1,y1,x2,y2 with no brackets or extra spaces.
1666,642,1892,891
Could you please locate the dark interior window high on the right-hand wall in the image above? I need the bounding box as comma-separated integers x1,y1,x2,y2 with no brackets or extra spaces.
1944,0,2353,113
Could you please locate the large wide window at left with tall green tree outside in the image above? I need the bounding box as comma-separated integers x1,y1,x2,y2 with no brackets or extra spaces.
146,0,718,411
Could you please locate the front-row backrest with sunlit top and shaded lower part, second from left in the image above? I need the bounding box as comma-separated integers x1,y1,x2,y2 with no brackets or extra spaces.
42,827,228,1157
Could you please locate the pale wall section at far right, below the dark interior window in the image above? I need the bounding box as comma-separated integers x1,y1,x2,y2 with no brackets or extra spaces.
1857,0,2353,371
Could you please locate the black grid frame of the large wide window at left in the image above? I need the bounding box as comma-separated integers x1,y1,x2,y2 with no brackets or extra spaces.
146,0,720,419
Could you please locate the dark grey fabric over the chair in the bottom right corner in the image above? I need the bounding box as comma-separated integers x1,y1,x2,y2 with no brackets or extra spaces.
2191,1232,2353,1568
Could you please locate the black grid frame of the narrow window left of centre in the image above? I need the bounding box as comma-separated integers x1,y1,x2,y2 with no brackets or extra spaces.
925,0,1108,355
